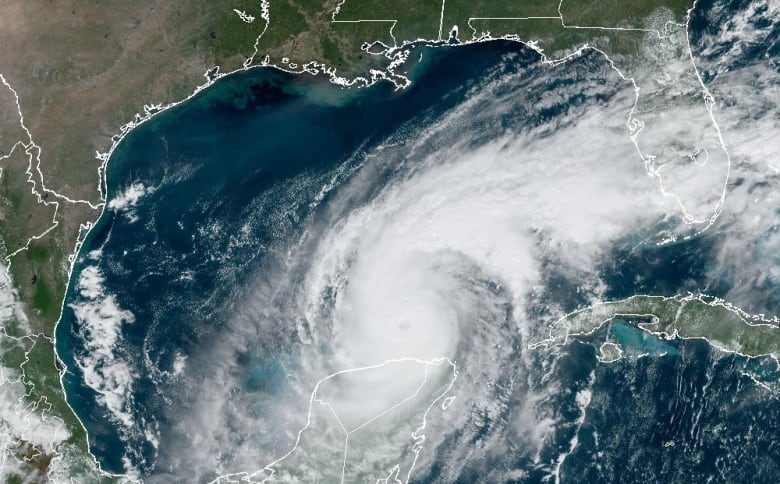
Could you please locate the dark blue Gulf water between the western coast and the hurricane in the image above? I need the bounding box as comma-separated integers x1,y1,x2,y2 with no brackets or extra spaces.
56,42,538,476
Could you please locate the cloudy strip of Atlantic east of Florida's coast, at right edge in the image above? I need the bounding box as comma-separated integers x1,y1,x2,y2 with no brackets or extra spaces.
693,2,780,315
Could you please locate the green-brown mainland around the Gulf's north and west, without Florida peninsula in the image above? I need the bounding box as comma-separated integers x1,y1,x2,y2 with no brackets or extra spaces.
0,0,708,482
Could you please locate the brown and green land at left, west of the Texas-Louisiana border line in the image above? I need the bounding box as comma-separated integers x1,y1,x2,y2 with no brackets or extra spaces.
0,0,265,482
